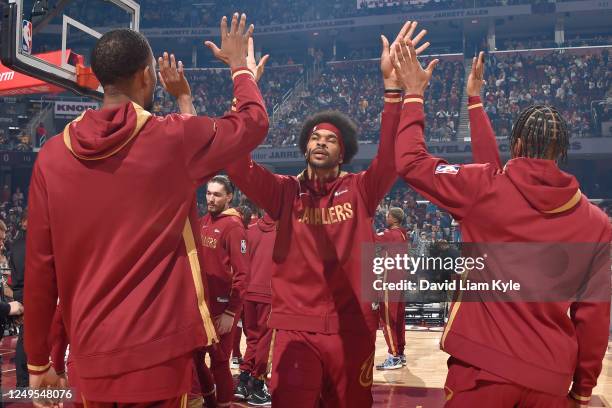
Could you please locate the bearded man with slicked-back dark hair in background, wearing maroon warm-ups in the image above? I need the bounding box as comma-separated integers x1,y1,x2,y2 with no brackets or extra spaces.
200,175,249,407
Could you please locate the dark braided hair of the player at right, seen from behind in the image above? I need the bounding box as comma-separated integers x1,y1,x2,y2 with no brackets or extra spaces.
510,105,569,161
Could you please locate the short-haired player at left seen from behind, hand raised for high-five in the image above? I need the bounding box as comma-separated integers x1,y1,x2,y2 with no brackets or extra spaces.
24,14,268,407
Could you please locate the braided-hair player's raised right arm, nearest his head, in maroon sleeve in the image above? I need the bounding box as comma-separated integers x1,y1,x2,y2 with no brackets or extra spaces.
467,51,502,169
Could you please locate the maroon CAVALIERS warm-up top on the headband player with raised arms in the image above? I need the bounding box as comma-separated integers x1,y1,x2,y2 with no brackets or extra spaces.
226,97,401,333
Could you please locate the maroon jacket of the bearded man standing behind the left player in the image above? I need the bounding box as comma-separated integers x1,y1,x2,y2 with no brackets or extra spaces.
200,208,250,316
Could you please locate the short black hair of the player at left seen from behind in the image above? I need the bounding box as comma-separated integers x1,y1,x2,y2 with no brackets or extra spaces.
91,28,152,86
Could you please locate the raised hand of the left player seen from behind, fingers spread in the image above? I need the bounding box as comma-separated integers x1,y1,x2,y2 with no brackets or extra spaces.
204,13,255,69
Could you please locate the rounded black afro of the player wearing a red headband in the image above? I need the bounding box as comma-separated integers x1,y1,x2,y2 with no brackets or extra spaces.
299,110,359,164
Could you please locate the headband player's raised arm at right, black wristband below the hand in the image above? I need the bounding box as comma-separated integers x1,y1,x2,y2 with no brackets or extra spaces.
361,21,429,214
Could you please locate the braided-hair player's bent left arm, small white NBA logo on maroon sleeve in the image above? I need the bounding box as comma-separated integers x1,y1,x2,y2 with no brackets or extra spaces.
393,39,492,219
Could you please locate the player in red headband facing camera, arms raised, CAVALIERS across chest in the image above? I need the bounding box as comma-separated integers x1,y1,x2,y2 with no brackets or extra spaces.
226,23,428,408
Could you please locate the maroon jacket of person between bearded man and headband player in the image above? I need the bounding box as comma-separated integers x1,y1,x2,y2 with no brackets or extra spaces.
245,214,276,303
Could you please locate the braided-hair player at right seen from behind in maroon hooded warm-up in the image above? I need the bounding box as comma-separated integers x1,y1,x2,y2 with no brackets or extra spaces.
394,39,612,408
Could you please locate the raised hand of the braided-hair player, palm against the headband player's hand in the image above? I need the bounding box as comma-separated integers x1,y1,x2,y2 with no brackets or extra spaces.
391,40,440,95
